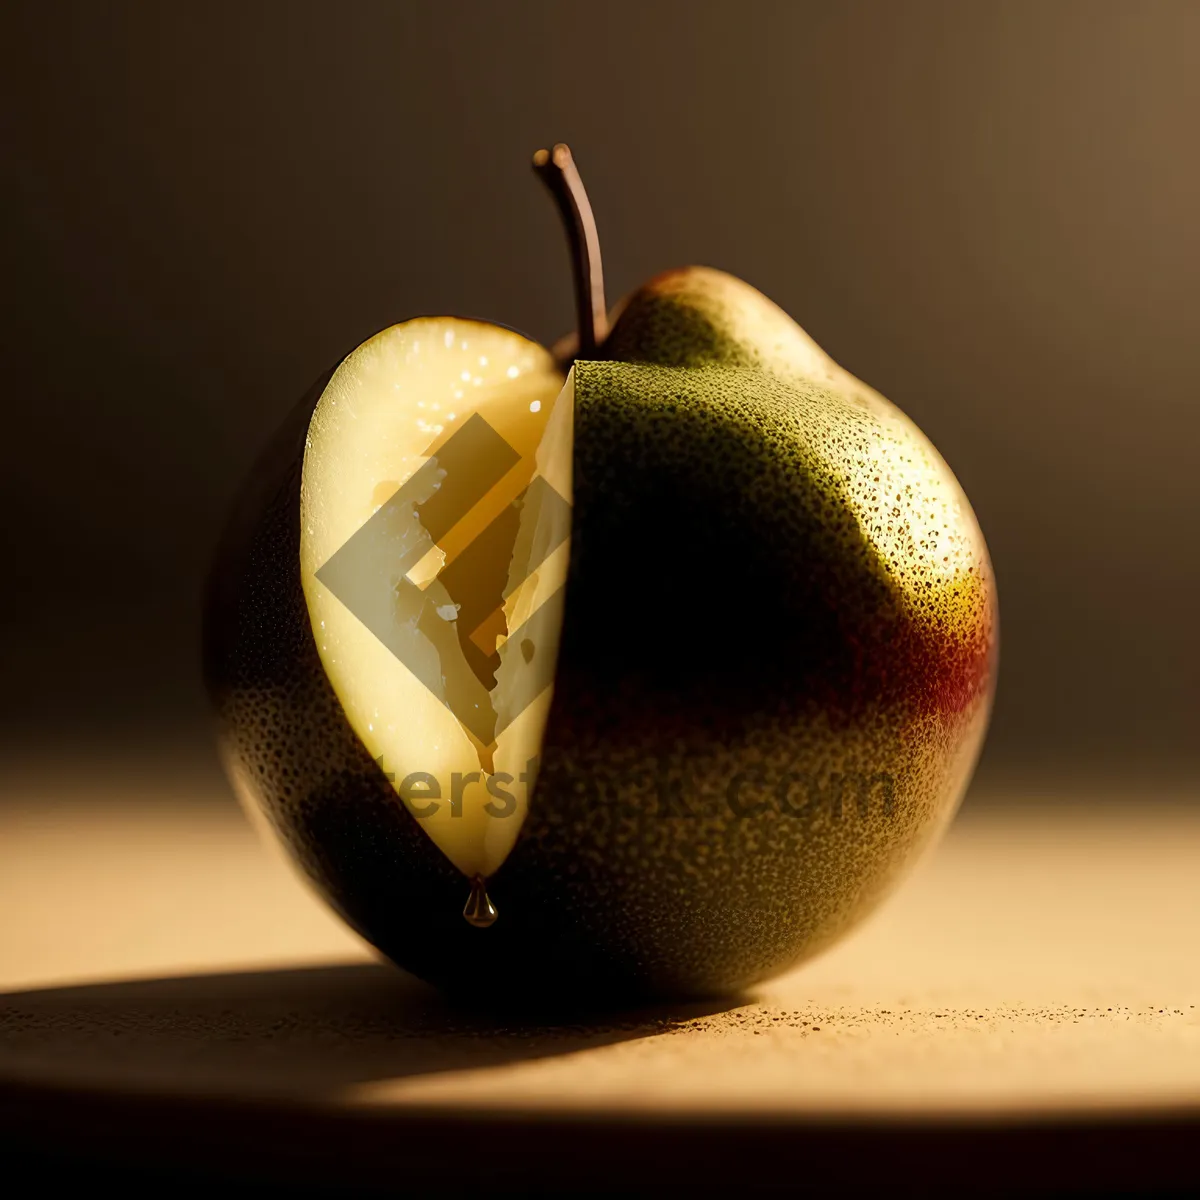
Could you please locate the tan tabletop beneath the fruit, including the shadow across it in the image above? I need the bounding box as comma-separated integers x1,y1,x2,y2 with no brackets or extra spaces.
0,770,1200,1190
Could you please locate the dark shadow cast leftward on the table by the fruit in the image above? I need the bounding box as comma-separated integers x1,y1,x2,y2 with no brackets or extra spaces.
0,964,746,1100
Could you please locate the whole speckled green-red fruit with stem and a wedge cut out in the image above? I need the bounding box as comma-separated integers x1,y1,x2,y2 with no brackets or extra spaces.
205,146,996,1001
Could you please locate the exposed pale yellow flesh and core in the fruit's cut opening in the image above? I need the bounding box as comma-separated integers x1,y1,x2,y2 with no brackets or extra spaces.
300,318,572,877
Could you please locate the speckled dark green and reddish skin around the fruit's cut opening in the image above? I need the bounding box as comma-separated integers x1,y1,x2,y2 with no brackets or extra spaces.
206,272,995,1002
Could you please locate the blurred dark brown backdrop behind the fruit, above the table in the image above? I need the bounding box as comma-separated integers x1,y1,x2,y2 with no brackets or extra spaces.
0,7,1200,796
